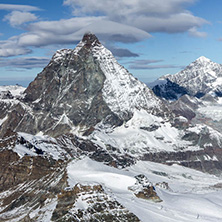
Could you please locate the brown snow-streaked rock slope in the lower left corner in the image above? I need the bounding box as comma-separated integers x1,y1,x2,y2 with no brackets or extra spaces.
0,147,67,221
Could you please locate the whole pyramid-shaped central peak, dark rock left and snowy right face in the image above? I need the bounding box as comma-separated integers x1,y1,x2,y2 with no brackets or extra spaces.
2,33,165,136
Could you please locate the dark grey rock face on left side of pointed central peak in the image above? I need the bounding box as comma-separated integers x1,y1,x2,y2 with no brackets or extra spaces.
21,34,121,136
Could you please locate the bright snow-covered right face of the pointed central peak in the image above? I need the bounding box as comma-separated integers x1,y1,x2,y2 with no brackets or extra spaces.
92,38,163,116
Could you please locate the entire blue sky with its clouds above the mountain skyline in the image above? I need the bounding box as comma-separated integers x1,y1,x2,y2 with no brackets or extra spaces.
0,0,222,86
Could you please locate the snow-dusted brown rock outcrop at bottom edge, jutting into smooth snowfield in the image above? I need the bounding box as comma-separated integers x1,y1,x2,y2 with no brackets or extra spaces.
52,184,140,222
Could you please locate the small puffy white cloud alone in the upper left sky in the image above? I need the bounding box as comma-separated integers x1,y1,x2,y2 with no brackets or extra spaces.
3,11,38,26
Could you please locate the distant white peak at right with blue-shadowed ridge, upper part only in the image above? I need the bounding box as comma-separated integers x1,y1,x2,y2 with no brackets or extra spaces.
151,56,222,99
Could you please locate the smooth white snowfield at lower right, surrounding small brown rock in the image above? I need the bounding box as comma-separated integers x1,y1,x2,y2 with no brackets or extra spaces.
67,157,222,222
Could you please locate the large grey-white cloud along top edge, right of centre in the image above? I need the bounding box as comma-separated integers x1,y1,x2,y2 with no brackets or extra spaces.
64,0,208,33
